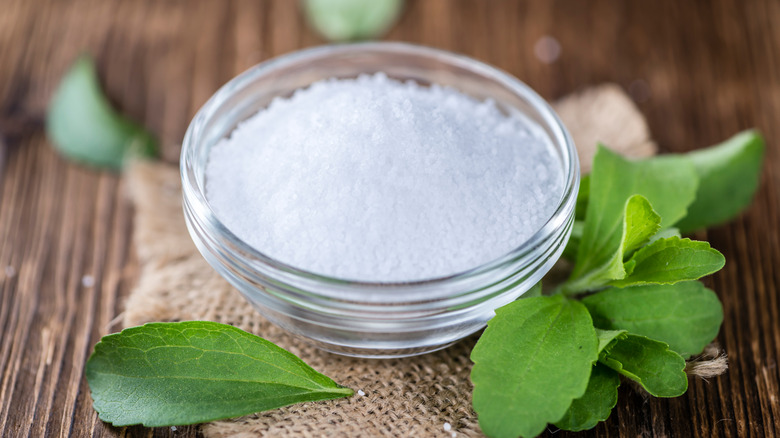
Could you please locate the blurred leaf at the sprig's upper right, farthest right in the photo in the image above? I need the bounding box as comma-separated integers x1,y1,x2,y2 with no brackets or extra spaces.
677,131,765,233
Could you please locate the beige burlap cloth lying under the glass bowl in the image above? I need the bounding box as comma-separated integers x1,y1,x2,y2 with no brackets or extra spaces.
124,85,672,437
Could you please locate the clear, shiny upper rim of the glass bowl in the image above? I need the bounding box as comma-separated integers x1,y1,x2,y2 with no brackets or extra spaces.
180,42,580,296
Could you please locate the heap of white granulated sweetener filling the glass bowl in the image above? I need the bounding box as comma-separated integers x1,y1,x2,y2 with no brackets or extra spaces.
206,73,563,282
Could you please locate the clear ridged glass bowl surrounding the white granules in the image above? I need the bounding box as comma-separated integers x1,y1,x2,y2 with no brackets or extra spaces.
181,43,579,358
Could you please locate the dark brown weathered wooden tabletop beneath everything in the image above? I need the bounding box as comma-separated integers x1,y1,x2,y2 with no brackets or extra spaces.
0,0,780,437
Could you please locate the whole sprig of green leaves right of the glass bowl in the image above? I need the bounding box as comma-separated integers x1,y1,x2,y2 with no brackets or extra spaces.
471,131,764,438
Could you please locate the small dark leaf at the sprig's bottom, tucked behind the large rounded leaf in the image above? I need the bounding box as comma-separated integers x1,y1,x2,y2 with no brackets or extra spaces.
555,364,620,432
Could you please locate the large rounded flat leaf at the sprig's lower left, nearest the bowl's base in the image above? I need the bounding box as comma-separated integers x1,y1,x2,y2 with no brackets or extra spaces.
471,295,598,438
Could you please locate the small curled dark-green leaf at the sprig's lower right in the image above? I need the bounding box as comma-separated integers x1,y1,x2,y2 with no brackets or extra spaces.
599,334,688,397
